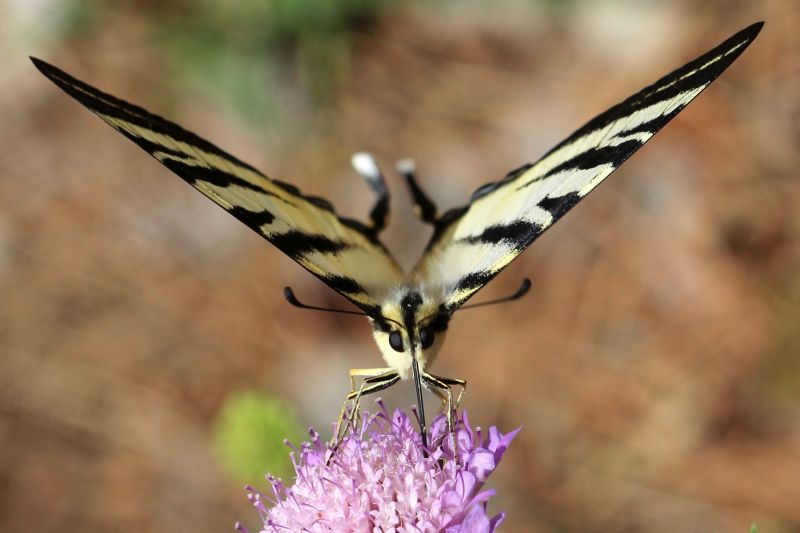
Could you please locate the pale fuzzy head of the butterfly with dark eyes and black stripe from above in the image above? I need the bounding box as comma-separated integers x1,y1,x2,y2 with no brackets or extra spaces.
372,289,450,379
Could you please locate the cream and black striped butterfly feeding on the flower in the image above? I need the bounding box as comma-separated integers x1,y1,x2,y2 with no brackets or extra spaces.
31,22,763,449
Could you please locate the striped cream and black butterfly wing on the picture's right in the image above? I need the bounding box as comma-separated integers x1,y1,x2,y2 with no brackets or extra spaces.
415,22,763,312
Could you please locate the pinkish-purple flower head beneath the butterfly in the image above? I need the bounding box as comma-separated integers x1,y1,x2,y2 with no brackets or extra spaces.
237,401,519,533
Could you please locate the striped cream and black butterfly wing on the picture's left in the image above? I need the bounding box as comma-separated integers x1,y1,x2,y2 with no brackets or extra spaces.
31,58,402,312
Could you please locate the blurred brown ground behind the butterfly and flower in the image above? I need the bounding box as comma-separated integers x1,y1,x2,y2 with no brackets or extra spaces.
0,0,800,533
